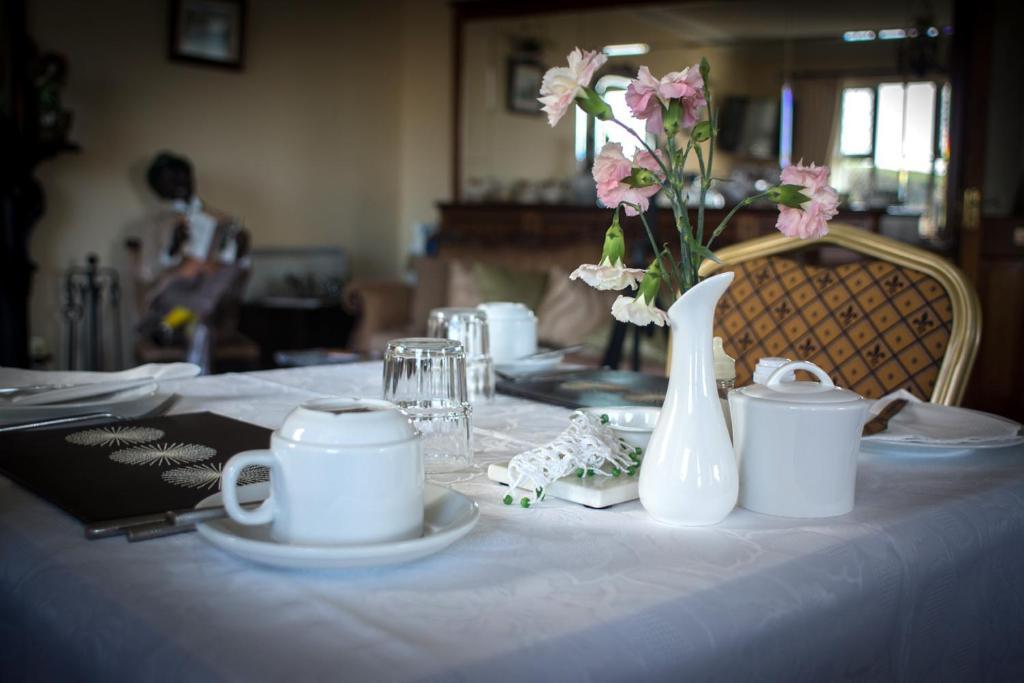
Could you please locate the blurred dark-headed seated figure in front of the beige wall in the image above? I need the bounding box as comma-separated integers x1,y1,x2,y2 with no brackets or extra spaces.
129,153,250,373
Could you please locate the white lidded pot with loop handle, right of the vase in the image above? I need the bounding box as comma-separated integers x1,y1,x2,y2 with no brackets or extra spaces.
729,360,870,517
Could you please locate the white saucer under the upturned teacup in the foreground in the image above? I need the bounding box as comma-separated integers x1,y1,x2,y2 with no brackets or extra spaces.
196,482,480,569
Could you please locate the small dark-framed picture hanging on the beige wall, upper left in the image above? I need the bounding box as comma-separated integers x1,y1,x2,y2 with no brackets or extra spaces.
169,0,246,69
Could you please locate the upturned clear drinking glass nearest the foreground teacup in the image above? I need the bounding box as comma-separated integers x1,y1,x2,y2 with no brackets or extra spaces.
384,337,473,473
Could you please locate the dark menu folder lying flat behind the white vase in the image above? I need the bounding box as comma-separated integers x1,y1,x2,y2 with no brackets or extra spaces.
496,370,669,408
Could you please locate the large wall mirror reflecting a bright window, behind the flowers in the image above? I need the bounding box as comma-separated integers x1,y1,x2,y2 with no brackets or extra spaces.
455,0,952,241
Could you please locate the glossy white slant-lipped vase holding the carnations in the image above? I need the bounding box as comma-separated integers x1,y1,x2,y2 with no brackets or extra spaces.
640,272,739,526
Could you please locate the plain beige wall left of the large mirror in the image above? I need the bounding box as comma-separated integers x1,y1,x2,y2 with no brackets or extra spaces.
29,0,451,362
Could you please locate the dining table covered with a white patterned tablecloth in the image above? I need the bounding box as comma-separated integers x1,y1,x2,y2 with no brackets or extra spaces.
0,362,1024,682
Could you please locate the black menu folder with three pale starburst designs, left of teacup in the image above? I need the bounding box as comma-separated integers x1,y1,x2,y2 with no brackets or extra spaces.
0,413,270,523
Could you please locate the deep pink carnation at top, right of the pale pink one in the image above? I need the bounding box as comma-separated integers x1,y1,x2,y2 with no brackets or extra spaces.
626,65,708,135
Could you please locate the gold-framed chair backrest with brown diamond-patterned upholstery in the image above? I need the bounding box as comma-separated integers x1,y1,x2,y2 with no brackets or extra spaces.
701,225,981,404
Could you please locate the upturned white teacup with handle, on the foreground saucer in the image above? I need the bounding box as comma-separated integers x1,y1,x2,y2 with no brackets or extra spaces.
221,398,423,545
